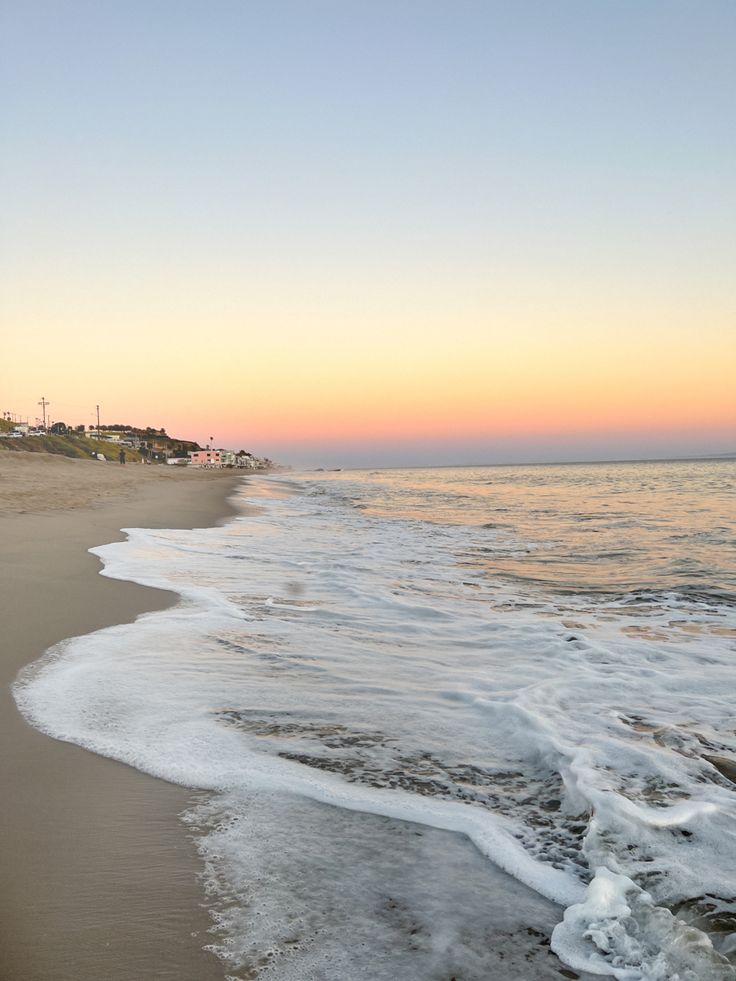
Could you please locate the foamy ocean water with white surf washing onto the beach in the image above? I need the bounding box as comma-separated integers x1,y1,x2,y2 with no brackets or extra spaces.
15,461,736,981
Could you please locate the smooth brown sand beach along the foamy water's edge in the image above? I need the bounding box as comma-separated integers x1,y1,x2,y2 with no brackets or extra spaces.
0,451,247,981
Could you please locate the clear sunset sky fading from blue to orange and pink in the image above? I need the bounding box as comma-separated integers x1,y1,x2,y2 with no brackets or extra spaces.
0,0,736,466
